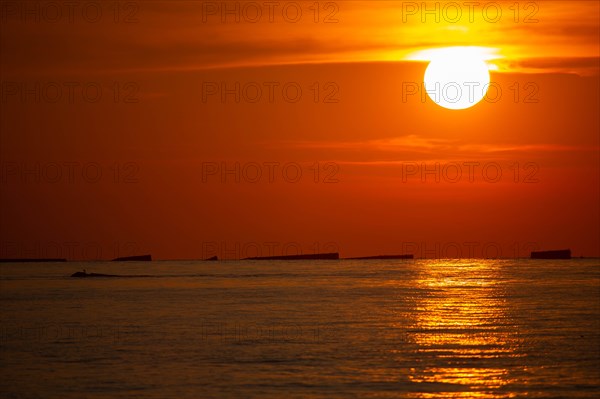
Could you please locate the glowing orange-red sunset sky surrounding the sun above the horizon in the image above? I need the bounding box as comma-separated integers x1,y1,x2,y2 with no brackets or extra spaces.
0,1,600,259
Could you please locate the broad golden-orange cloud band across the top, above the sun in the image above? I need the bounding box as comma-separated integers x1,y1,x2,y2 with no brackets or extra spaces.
0,1,600,74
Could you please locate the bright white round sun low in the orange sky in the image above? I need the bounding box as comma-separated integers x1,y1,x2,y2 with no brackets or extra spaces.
423,47,490,110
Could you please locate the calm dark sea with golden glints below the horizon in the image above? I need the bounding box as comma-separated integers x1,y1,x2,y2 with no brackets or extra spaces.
0,259,600,399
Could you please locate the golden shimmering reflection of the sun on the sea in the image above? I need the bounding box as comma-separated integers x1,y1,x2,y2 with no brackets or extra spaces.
408,259,523,398
